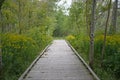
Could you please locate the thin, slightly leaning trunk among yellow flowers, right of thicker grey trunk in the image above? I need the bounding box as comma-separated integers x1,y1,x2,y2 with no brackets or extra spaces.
101,0,112,65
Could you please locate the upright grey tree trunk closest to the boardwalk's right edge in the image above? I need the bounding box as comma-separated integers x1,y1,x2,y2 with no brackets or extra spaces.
89,0,96,68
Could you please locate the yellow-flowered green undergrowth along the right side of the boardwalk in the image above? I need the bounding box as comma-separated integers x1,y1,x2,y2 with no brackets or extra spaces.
67,35,120,80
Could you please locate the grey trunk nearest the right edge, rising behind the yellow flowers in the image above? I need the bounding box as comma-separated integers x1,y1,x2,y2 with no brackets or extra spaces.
109,0,118,34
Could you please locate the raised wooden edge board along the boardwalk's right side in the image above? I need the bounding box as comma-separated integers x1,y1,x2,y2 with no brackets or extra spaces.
66,40,100,80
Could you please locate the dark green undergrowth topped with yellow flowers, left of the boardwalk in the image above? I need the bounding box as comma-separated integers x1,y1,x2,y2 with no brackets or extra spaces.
0,34,39,80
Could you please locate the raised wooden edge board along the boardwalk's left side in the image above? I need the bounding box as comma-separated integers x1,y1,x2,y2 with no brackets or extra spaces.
18,44,51,80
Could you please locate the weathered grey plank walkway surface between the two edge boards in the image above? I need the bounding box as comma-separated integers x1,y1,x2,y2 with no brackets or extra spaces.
19,40,99,80
